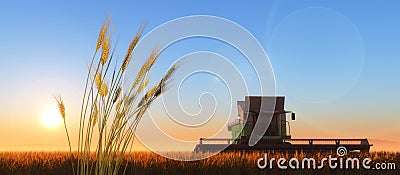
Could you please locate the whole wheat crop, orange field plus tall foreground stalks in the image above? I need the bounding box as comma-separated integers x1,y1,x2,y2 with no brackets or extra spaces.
24,17,400,175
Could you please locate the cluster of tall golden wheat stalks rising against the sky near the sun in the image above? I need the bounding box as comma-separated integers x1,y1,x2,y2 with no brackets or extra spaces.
56,18,177,174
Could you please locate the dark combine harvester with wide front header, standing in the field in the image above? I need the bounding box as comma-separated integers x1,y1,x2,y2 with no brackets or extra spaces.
194,96,372,152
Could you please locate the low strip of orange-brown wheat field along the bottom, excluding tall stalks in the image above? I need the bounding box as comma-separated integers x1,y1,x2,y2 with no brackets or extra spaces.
0,152,400,175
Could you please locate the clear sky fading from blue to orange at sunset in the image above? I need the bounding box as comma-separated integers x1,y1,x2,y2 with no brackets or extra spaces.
0,0,400,150
